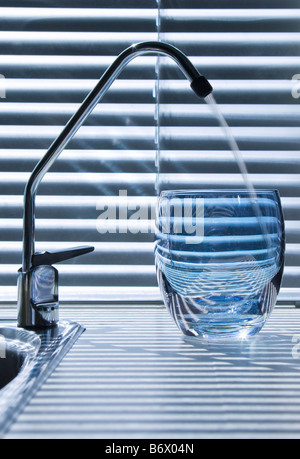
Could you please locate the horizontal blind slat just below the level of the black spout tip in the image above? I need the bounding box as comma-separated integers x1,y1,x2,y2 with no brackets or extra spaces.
0,103,300,127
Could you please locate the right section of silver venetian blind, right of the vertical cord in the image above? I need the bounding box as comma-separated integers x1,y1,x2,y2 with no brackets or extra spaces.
159,0,300,310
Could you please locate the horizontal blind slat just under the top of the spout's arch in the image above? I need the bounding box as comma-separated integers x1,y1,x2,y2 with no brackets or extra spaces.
0,54,300,79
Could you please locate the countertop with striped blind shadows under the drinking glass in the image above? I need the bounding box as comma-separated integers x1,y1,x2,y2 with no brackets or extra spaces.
1,305,300,439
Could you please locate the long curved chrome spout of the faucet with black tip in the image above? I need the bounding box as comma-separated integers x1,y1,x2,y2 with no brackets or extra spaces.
18,41,212,327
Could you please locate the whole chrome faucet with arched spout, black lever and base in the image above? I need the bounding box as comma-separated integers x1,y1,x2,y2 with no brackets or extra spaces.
18,42,212,329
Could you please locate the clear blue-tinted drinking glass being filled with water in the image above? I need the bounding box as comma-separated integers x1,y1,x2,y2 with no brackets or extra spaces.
155,190,285,339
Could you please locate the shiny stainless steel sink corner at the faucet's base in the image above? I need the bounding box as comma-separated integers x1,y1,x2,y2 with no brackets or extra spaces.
0,320,84,437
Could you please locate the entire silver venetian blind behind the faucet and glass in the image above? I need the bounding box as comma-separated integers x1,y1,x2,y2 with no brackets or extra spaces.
0,0,300,308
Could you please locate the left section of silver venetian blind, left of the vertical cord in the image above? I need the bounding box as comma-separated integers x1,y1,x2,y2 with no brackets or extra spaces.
0,0,159,302
